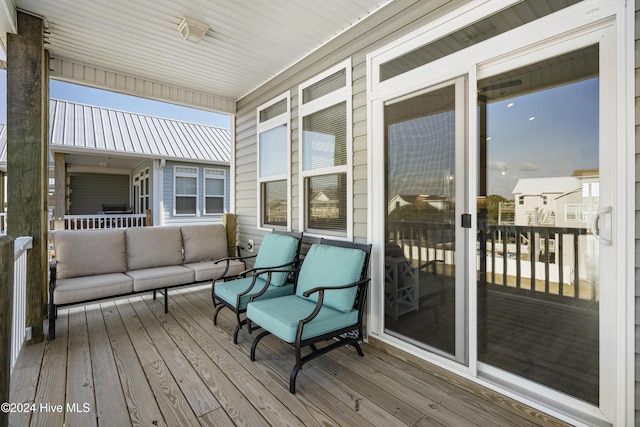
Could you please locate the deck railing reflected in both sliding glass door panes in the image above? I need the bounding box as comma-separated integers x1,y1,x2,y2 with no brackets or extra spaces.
387,221,599,305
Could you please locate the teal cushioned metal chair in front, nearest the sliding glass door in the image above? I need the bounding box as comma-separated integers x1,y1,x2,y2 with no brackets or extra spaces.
246,239,371,393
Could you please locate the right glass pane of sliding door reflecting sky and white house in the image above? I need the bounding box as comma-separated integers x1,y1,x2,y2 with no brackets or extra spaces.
477,46,601,404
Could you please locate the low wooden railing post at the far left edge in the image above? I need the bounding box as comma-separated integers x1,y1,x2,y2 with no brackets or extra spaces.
0,236,13,427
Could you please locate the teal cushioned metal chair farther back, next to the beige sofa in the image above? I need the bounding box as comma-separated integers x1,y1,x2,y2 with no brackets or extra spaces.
211,231,302,344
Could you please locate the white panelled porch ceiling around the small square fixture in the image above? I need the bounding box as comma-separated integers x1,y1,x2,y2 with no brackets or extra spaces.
6,0,391,112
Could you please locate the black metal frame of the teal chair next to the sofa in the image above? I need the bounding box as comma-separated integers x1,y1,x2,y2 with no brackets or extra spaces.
211,230,303,344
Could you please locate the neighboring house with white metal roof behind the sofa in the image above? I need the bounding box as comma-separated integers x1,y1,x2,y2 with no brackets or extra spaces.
0,100,231,225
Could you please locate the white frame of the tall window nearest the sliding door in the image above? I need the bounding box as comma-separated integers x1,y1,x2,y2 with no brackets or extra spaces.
298,58,353,240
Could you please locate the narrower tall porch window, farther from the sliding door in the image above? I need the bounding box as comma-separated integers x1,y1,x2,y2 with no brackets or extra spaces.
257,93,291,228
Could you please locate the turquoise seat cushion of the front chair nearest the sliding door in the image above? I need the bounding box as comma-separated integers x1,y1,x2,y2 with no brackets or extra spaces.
247,295,358,343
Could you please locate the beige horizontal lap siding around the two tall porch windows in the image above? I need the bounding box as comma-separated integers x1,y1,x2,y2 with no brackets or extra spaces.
235,0,468,251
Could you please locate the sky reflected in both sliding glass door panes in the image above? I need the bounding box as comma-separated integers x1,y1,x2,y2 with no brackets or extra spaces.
388,78,599,199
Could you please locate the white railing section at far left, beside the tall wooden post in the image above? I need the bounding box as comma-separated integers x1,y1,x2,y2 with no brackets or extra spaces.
11,237,33,371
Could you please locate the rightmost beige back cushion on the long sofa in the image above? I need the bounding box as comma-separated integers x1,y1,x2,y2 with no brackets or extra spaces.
180,224,228,263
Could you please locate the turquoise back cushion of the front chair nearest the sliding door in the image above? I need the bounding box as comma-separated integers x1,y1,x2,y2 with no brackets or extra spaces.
296,245,365,312
